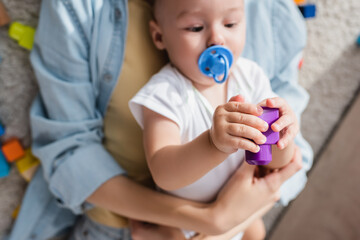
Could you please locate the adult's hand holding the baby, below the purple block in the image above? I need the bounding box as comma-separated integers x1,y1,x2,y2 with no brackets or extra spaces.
212,148,302,232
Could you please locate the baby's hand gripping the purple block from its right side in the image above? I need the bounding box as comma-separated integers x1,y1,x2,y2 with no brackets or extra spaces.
259,97,299,150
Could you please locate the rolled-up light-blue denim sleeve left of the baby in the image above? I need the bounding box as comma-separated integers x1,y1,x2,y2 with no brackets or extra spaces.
30,0,124,213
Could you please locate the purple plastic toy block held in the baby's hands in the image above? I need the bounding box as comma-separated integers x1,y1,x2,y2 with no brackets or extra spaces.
245,107,280,165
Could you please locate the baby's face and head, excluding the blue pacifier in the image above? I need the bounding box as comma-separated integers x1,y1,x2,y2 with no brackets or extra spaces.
150,0,245,85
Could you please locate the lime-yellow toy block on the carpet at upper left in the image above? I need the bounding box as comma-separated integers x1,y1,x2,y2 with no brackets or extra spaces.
9,22,35,50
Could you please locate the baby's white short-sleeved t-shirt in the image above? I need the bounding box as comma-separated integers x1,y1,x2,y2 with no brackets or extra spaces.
129,58,276,202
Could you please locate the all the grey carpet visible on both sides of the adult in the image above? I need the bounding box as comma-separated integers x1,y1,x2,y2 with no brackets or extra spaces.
0,0,360,238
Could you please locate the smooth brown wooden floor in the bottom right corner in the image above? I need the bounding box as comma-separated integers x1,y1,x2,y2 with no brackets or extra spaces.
270,92,360,240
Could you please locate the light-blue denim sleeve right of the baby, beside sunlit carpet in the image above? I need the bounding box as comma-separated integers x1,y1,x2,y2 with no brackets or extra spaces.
271,0,313,205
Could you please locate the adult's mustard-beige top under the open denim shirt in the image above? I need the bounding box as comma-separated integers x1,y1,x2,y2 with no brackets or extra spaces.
87,0,167,227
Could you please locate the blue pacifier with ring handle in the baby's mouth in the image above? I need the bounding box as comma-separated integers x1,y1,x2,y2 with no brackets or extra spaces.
198,45,233,83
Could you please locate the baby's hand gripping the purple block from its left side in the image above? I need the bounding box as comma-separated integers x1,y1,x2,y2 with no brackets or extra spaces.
210,95,268,153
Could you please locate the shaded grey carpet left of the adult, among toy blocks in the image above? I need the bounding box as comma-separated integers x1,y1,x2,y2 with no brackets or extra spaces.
0,0,40,239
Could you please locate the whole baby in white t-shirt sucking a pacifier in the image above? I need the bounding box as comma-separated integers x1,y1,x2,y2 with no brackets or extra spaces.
129,0,299,239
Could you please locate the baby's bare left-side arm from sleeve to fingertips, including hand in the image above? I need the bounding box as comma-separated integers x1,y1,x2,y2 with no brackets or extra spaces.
143,98,267,190
